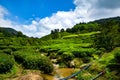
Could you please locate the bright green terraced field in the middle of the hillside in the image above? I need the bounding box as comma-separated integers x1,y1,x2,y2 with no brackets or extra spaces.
41,32,94,51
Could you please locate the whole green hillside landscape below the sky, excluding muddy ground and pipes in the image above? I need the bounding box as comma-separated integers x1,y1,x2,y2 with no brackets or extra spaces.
0,17,120,80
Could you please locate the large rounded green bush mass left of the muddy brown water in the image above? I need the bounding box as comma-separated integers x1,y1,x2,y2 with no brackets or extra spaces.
14,49,53,73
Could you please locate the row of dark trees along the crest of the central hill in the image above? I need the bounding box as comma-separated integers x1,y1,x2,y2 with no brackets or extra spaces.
51,22,99,34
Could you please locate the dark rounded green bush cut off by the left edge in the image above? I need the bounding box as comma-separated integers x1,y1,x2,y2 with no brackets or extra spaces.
0,53,14,73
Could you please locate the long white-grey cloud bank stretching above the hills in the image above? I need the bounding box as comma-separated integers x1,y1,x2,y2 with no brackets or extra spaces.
0,0,120,37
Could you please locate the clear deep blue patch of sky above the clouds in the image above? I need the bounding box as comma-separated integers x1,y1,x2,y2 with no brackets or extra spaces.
0,0,75,23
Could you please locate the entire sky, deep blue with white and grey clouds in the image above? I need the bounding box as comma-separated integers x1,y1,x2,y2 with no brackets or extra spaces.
0,0,120,37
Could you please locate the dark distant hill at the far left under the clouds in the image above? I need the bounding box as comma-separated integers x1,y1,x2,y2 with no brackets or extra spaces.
0,27,27,37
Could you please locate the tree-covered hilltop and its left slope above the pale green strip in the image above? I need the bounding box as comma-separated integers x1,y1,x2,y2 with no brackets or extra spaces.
41,22,100,40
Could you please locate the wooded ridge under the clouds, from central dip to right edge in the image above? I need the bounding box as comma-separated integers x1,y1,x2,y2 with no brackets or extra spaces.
41,17,120,40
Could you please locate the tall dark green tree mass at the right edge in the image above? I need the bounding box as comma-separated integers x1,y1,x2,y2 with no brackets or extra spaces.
94,20,120,51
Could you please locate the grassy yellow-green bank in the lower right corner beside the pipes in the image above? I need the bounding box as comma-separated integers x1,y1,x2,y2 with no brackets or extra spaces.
78,47,120,80
